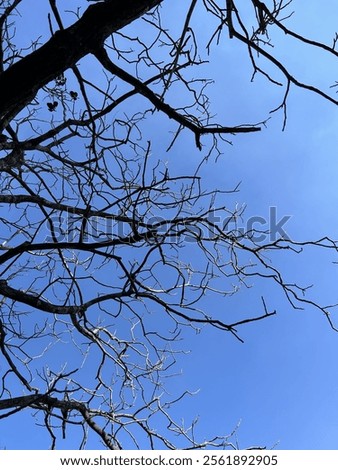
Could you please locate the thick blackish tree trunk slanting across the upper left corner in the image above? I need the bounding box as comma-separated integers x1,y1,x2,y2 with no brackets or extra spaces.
0,0,163,127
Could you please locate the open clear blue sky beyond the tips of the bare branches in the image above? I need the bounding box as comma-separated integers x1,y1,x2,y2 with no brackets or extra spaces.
0,0,338,449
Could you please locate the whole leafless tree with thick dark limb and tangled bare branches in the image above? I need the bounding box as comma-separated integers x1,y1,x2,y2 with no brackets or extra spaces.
0,0,337,449
